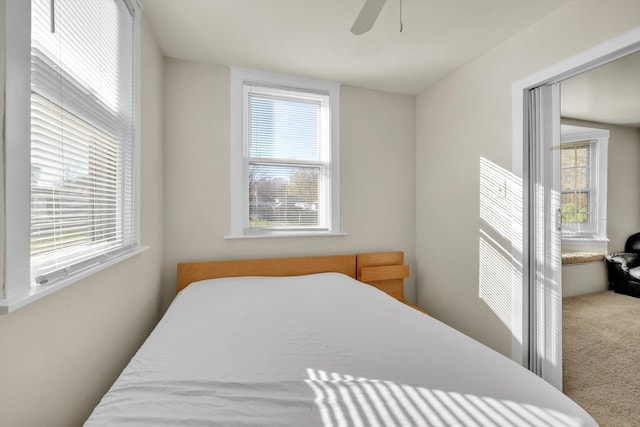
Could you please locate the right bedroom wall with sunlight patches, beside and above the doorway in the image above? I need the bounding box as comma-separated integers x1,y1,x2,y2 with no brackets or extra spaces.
416,0,640,356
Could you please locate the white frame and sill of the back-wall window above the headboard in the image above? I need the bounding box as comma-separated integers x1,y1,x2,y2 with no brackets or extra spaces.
225,67,345,239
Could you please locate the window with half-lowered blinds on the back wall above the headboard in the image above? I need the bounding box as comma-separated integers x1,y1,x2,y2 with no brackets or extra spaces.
231,68,339,237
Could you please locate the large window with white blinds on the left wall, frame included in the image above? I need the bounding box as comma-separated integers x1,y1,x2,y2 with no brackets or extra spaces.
5,0,139,305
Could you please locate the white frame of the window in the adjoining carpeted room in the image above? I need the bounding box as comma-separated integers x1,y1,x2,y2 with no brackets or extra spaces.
561,125,610,253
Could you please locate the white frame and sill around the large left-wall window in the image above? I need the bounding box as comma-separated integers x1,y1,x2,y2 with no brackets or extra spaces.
0,0,148,314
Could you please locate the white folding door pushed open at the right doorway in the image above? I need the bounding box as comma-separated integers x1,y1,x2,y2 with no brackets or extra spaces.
528,83,562,390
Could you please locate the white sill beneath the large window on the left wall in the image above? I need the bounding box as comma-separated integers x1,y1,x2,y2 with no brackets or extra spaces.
0,246,149,314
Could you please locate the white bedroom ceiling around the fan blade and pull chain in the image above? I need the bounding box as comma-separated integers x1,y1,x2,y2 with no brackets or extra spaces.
143,0,568,94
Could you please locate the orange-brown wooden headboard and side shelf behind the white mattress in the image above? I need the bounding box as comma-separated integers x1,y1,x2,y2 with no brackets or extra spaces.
177,251,426,313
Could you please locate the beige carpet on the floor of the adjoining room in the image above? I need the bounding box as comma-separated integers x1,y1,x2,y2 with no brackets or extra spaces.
562,291,640,427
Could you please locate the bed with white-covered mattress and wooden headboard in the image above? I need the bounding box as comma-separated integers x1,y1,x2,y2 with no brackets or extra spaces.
85,252,597,427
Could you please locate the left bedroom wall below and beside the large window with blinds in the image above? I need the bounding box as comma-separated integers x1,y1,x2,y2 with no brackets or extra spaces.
0,15,163,427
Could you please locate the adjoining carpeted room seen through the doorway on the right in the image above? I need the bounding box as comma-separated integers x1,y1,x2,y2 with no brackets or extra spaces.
561,53,640,425
